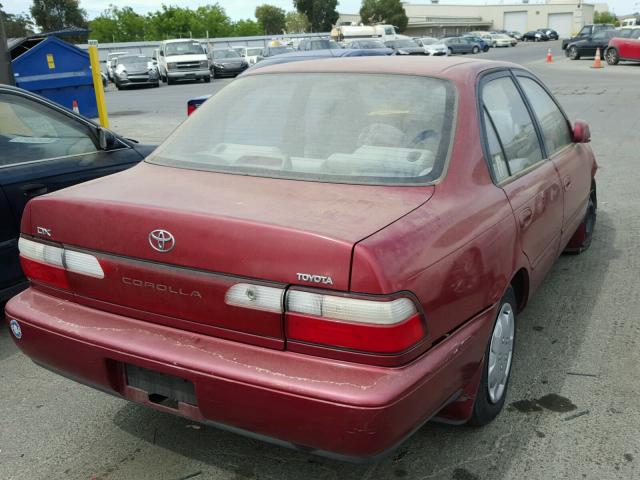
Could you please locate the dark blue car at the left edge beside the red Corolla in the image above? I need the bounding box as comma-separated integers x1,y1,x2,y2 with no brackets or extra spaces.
0,85,153,303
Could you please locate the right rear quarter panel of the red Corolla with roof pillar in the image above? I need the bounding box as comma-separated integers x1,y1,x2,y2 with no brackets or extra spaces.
351,67,528,342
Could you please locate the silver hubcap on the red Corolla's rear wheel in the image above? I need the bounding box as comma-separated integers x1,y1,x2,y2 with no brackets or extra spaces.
487,303,515,403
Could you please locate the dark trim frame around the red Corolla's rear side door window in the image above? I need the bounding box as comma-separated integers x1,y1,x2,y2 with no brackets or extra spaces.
476,68,548,188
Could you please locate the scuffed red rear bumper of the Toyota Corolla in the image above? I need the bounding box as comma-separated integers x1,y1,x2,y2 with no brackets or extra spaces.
6,288,494,459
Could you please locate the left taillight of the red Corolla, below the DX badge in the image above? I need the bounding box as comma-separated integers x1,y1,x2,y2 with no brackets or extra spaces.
18,237,104,290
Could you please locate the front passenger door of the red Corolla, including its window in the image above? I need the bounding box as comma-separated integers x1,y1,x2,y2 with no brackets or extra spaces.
516,72,592,248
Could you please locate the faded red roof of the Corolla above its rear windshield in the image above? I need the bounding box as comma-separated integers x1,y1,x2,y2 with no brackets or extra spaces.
245,56,524,80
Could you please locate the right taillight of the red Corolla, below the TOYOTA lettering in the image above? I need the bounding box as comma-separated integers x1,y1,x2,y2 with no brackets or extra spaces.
225,283,426,354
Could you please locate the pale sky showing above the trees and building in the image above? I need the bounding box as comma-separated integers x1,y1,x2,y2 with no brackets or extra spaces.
0,0,640,20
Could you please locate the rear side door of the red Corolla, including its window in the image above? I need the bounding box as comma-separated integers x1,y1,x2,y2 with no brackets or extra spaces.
480,71,563,289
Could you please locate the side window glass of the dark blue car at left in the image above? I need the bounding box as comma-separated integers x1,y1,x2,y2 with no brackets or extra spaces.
0,93,97,167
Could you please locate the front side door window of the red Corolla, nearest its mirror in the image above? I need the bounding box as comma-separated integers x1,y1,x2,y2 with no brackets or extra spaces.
518,77,573,156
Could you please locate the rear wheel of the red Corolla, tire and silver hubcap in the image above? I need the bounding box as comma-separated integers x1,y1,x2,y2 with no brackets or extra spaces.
467,286,518,426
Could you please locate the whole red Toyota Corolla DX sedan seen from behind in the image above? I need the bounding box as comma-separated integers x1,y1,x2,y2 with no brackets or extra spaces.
6,57,596,458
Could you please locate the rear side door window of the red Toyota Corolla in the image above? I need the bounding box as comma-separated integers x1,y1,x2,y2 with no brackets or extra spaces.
481,76,543,177
